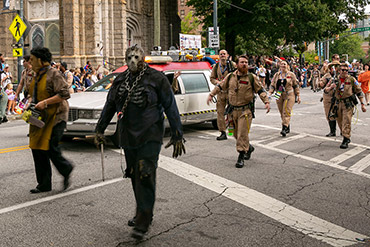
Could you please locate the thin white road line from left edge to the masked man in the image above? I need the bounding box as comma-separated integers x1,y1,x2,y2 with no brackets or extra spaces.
0,178,123,215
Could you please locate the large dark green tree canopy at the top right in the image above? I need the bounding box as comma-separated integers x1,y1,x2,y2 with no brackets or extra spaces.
187,0,370,55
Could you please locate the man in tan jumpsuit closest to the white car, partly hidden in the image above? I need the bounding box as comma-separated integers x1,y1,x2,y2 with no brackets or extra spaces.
210,50,235,141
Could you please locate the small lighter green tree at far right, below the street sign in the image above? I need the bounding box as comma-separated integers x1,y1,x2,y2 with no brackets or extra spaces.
330,34,365,61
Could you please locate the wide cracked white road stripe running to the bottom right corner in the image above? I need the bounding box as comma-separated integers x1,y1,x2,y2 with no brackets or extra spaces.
159,156,367,247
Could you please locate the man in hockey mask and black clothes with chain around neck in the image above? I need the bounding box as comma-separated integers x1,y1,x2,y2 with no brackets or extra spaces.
95,45,185,240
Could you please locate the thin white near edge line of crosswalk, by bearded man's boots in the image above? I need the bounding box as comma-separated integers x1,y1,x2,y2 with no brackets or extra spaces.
199,130,370,178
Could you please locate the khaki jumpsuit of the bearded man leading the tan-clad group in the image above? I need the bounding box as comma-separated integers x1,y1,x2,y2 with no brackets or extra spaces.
211,71,269,152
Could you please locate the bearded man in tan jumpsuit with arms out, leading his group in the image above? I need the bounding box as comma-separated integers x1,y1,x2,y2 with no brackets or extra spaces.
207,55,270,168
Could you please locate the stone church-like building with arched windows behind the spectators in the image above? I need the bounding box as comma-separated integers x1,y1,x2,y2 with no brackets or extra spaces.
0,0,181,75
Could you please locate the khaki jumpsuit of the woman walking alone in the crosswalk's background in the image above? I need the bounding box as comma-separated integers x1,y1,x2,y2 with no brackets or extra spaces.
269,71,299,127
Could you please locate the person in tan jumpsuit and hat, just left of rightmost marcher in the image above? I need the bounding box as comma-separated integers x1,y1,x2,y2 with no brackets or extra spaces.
320,59,340,137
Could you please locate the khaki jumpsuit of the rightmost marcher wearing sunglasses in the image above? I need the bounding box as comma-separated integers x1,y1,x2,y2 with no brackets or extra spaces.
331,75,363,139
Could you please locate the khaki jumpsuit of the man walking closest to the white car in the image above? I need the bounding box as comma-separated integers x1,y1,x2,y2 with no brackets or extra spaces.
210,62,236,131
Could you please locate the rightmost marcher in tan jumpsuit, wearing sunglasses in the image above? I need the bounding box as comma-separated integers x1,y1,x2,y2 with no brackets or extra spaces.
325,63,366,149
